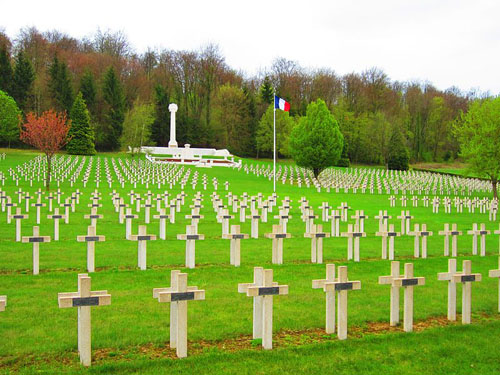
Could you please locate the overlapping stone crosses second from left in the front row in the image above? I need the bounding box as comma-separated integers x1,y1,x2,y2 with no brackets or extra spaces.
153,270,205,358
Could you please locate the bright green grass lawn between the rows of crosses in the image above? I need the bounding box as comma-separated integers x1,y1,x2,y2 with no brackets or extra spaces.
0,150,500,374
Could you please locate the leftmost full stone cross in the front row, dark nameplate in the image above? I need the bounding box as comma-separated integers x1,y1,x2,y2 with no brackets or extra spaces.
57,273,111,367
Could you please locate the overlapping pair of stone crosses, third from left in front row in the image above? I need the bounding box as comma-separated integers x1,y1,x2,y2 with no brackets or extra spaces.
238,267,288,349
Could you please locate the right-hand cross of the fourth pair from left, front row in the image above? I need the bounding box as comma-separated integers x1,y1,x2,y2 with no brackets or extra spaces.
323,266,361,340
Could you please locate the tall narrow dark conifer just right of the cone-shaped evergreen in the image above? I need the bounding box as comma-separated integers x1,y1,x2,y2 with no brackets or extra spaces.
102,67,125,151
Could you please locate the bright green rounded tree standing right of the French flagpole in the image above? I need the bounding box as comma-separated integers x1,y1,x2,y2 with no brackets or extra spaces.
290,99,344,177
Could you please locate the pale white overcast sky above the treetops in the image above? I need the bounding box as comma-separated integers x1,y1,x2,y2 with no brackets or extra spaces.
0,0,500,95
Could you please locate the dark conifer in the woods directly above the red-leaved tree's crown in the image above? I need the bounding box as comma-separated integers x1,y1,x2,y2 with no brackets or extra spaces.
49,56,74,113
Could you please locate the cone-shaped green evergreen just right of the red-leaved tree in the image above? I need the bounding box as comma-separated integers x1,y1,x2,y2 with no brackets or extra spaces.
66,92,95,155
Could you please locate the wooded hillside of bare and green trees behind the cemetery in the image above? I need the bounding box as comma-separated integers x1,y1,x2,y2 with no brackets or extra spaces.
0,28,488,164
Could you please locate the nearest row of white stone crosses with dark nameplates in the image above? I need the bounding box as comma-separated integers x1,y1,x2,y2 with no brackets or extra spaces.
0,258,500,366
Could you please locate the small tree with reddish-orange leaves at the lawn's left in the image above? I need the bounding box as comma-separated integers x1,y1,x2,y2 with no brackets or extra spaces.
20,110,71,190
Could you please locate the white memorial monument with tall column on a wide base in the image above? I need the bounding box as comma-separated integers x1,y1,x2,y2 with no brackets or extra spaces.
141,103,241,168
